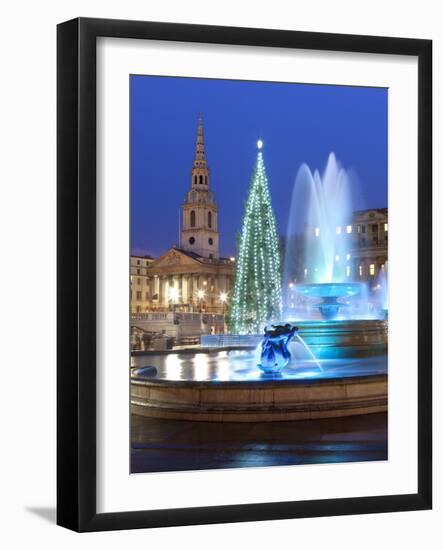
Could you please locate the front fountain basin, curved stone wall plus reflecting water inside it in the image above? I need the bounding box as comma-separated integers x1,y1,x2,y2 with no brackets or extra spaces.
131,350,387,422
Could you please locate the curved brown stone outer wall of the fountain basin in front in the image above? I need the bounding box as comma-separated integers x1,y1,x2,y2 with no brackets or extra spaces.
131,375,388,422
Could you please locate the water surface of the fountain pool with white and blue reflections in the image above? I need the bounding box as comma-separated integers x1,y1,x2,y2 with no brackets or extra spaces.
131,350,387,382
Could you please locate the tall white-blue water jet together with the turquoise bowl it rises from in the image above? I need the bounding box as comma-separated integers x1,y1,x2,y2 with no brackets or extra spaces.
284,153,372,320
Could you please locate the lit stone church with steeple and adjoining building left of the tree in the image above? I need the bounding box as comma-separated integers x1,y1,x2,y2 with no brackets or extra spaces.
131,116,234,315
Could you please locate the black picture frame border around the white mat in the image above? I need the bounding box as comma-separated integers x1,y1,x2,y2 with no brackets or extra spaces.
57,18,432,531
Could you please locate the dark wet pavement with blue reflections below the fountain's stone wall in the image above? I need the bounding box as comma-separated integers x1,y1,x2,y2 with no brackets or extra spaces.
131,413,388,473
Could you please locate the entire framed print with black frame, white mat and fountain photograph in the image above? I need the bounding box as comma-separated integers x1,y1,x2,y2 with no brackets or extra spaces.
57,19,432,531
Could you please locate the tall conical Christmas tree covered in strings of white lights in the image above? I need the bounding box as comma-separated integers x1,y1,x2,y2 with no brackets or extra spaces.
230,141,281,334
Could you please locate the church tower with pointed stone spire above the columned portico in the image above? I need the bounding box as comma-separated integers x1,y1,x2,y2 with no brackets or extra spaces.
180,115,219,259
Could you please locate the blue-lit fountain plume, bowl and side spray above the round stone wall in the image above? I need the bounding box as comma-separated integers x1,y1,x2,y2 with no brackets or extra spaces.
283,153,386,321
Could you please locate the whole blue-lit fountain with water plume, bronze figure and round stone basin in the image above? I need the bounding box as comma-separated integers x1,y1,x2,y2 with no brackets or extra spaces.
131,154,387,422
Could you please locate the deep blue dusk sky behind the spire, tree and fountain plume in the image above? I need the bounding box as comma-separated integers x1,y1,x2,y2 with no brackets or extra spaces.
130,76,388,257
